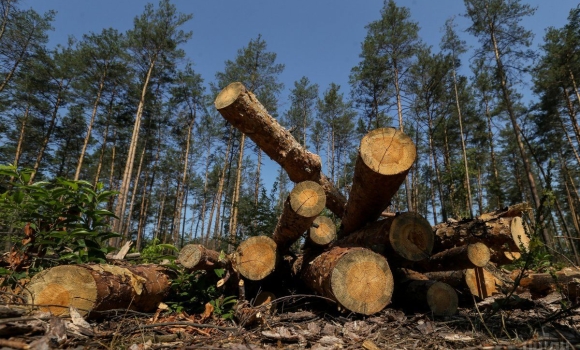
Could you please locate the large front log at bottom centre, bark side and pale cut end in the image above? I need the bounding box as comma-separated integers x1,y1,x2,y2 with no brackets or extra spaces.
301,247,393,315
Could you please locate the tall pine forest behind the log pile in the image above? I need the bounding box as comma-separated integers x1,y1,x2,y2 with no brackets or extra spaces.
0,0,580,262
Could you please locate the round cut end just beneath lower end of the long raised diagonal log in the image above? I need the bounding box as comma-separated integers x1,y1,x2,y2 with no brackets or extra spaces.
290,181,326,218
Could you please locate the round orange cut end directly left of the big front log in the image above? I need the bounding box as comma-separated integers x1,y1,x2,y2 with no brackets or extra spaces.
235,236,276,281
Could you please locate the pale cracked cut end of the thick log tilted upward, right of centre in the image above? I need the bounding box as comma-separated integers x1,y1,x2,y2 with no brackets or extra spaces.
360,128,417,175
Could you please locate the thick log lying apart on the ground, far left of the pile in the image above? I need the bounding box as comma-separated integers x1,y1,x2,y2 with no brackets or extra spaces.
24,264,170,316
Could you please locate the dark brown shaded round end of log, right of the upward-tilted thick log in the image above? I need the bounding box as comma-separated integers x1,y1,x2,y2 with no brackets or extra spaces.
389,212,435,261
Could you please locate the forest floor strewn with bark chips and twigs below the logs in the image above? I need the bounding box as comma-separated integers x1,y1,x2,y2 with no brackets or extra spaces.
0,294,580,350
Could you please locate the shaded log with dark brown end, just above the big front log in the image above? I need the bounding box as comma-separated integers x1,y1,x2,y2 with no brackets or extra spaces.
337,212,434,261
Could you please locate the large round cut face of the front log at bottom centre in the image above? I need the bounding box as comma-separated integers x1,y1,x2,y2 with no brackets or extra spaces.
331,249,394,315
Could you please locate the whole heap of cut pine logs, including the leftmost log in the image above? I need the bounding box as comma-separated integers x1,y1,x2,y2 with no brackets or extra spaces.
27,83,556,315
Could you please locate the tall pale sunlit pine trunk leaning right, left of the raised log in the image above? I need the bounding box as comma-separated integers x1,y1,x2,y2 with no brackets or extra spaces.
114,58,156,238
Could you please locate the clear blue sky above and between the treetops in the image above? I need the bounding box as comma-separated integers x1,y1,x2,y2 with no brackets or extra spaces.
21,0,578,194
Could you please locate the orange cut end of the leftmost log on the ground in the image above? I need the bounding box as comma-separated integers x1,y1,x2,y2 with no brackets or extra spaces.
26,265,97,316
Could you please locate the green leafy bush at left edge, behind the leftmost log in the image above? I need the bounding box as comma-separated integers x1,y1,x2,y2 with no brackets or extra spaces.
0,165,119,263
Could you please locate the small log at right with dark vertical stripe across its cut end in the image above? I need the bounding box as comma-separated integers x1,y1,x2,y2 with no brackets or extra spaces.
425,267,501,299
